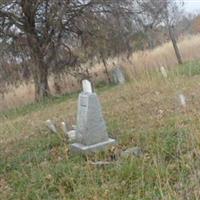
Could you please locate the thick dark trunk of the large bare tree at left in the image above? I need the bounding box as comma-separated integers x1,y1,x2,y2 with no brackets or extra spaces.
20,0,49,101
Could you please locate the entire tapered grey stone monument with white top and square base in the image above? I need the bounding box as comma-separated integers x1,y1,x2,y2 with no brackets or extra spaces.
71,80,115,154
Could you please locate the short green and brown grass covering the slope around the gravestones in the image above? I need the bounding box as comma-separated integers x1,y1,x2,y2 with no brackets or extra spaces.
0,62,200,200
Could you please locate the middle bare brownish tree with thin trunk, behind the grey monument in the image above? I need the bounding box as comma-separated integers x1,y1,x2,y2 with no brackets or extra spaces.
81,0,133,83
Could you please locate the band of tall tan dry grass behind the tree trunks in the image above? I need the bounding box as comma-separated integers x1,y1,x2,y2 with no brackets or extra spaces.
0,35,200,110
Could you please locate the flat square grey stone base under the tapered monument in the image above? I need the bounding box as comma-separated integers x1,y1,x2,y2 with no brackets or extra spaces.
71,138,116,154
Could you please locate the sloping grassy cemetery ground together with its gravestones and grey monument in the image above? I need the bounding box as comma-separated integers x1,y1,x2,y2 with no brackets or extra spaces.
0,62,200,199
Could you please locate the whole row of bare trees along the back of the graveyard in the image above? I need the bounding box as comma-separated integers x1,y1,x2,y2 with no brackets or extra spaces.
0,0,187,101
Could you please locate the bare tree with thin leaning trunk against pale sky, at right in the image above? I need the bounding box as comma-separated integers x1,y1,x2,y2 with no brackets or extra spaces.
134,0,183,64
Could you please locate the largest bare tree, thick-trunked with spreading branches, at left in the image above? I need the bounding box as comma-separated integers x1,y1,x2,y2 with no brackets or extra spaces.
0,0,131,101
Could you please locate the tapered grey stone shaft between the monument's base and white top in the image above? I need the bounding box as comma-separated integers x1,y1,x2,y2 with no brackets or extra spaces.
76,93,109,146
